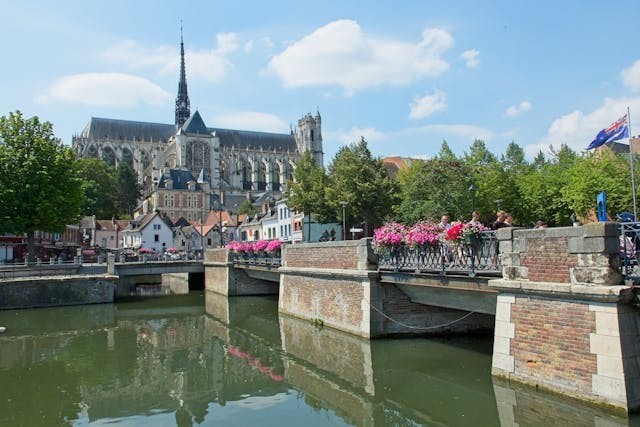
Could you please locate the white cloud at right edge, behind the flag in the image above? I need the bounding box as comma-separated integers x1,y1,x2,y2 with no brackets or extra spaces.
525,97,640,157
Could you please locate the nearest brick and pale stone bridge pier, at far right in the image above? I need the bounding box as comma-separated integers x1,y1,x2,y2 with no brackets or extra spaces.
489,222,640,411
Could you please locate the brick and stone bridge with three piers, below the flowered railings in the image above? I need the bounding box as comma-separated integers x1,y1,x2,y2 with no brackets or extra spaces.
205,223,640,410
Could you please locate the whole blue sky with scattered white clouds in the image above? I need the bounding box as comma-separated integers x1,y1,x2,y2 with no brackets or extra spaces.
0,0,640,165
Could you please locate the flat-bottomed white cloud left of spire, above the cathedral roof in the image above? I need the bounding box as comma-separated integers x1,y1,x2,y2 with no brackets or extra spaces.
36,73,171,107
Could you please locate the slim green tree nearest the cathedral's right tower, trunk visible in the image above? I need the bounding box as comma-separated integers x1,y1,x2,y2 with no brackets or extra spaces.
287,151,327,242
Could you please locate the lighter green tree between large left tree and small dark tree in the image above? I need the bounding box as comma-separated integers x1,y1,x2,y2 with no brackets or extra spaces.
78,158,118,219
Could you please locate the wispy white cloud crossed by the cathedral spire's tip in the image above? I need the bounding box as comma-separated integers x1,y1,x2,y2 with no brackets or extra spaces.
98,33,239,81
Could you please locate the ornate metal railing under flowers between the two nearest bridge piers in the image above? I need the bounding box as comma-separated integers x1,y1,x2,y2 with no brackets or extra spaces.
378,231,502,276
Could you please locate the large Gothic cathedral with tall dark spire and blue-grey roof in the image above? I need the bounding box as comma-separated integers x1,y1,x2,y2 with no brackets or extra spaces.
72,31,323,219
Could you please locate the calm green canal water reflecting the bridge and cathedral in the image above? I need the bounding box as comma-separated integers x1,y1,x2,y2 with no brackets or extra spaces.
0,291,636,427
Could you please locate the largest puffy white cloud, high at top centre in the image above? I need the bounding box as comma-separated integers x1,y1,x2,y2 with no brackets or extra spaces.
268,20,453,93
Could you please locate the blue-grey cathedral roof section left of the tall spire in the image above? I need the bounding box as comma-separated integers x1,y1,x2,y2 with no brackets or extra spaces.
81,117,176,141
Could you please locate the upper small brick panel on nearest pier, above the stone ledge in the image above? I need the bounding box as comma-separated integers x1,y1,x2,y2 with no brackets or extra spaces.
520,234,578,283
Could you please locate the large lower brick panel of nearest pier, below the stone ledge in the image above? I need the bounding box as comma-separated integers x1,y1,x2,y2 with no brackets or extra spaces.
511,297,597,390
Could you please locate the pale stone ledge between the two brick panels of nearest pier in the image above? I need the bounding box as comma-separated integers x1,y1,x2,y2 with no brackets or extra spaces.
489,279,635,303
